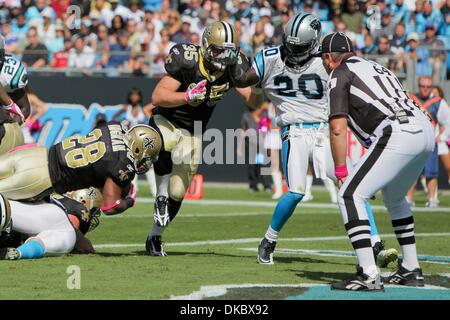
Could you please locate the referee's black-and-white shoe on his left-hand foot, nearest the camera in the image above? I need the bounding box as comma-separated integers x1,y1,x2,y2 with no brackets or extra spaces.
331,266,384,291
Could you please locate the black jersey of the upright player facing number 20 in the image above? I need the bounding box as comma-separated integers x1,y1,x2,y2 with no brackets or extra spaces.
153,44,251,132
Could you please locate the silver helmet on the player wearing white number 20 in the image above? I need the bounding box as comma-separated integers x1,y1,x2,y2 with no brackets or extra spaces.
283,12,322,69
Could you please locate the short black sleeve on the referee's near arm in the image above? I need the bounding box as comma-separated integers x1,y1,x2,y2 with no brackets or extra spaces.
327,67,351,119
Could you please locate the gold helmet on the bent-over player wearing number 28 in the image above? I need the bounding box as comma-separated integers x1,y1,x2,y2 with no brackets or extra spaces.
125,124,162,174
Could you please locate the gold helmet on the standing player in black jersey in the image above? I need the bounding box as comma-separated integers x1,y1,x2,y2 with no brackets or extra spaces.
201,21,239,71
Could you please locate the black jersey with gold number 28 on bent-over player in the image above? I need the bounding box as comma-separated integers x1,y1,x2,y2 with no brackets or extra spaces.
48,122,135,194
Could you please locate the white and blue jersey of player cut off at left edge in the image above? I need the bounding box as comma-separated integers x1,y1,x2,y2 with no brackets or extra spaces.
0,55,28,93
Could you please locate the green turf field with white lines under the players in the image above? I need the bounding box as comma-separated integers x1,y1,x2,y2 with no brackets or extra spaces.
0,186,450,299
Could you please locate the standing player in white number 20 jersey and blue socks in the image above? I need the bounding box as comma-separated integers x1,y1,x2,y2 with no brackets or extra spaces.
239,12,397,267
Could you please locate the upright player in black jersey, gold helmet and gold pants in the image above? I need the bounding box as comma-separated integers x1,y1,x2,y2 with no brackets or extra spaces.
146,21,263,256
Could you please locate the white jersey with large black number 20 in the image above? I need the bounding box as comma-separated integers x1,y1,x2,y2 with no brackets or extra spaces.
253,47,329,126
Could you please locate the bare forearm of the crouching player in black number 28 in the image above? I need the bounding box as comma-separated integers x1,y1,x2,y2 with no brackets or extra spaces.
101,178,135,216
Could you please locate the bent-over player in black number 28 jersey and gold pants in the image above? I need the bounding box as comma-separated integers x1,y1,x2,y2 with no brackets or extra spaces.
0,122,161,215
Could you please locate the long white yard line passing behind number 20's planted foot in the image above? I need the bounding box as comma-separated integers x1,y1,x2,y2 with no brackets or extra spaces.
94,232,450,249
